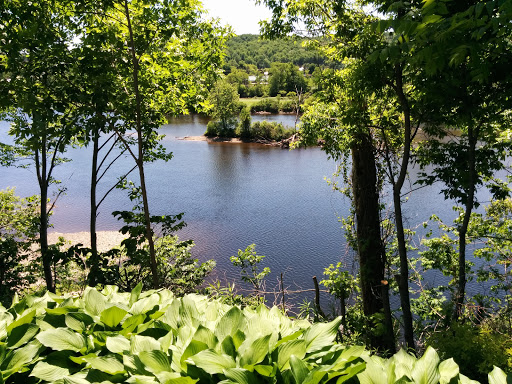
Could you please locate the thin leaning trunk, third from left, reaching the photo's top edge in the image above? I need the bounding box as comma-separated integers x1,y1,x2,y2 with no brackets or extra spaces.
124,0,159,289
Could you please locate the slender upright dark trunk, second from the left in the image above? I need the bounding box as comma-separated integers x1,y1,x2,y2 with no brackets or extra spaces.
88,130,99,287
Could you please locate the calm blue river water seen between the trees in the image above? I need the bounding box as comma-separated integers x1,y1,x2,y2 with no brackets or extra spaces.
0,115,496,302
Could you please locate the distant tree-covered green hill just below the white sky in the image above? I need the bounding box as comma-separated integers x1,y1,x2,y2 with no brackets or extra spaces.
225,35,327,69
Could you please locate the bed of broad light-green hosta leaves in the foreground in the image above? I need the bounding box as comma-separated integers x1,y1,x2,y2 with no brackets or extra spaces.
0,285,510,384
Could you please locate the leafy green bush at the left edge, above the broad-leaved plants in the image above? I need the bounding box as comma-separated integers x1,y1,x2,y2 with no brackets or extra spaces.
0,188,40,303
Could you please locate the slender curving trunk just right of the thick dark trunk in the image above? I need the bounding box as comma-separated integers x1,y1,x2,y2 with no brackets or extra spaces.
390,66,416,351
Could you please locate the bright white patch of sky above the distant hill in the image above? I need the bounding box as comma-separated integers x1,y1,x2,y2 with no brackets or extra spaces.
202,0,270,35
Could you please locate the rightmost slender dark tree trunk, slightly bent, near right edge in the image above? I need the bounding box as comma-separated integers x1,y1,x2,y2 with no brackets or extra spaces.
454,126,478,320
